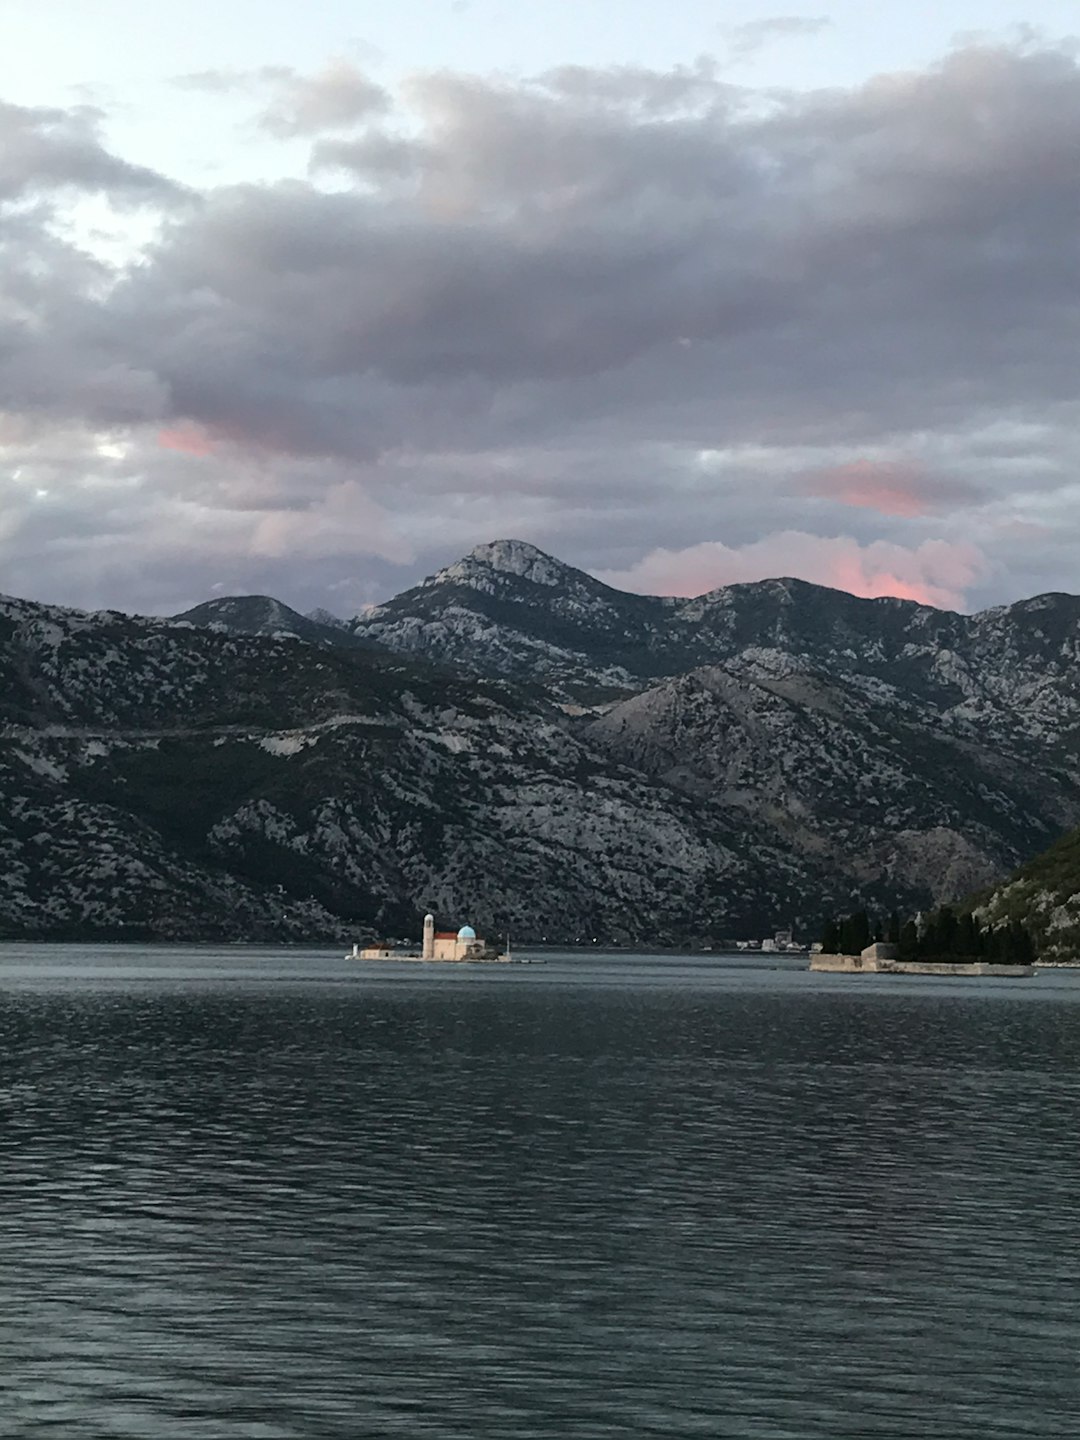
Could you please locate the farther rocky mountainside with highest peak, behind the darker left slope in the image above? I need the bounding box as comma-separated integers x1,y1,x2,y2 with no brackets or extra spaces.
354,541,1080,903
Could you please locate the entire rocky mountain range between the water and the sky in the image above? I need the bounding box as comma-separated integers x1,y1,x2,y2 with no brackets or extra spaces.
0,540,1080,943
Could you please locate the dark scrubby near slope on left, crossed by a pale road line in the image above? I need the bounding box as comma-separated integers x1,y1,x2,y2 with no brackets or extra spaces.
0,587,844,940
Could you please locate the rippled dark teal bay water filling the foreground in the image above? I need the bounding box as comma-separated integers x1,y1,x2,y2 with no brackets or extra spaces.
0,946,1080,1440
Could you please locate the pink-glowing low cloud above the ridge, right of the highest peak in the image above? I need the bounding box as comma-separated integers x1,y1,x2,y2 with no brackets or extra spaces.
599,530,988,611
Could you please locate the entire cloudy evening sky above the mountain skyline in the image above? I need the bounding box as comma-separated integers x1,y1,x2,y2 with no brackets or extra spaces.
0,0,1080,615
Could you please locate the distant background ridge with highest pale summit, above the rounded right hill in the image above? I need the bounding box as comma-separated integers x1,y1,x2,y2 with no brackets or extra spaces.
360,540,1080,720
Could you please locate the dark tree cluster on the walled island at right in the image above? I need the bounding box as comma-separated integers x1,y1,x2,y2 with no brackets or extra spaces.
821,904,1037,965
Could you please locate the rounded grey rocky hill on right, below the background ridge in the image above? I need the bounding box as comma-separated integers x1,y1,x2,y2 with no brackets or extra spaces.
588,667,1080,903
